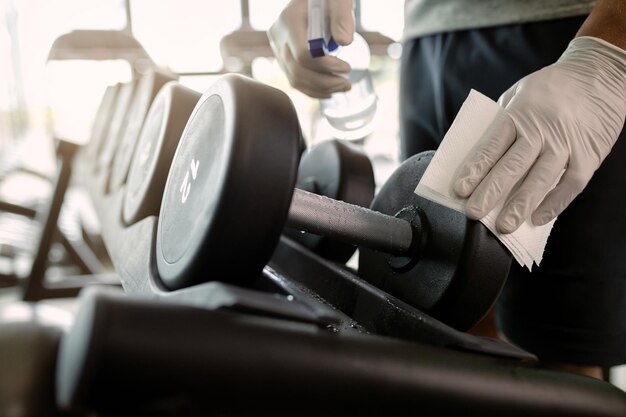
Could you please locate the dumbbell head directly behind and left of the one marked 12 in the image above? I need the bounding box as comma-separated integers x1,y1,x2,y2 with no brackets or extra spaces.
123,81,201,225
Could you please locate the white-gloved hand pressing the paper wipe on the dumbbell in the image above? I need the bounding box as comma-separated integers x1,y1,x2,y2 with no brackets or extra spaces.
454,36,626,233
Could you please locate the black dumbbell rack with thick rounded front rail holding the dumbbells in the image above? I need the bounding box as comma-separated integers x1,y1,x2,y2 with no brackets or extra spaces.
57,160,626,416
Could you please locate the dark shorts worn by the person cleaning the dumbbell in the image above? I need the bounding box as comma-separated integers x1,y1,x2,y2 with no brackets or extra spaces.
400,17,626,366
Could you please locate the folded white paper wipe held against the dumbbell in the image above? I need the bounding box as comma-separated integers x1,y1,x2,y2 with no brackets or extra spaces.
415,90,554,269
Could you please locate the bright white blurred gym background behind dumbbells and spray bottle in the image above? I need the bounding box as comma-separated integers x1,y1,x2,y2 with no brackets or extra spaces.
0,0,626,388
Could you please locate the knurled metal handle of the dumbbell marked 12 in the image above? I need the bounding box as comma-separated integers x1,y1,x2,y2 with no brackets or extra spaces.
287,188,413,255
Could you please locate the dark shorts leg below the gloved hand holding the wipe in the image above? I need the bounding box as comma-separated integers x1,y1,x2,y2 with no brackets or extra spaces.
498,122,626,367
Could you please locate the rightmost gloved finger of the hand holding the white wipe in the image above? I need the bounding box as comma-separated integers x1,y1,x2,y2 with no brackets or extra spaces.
531,165,594,226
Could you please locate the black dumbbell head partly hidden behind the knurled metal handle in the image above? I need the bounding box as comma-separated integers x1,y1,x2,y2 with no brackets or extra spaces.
284,140,376,263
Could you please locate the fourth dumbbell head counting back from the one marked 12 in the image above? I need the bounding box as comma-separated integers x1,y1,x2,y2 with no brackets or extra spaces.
96,81,137,177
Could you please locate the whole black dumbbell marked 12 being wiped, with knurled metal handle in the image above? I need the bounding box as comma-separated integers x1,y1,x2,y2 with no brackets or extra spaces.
154,74,511,330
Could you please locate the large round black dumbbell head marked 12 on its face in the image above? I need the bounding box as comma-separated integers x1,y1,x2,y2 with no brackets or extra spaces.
156,74,300,289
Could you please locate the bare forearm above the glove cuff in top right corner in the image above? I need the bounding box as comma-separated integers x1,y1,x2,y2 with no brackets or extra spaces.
576,0,626,50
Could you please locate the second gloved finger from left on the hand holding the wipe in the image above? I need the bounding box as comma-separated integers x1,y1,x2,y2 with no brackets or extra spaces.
465,137,540,219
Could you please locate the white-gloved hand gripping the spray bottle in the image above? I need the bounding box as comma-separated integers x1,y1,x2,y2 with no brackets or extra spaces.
267,0,354,98
